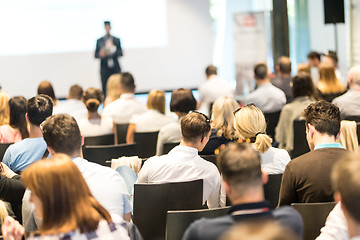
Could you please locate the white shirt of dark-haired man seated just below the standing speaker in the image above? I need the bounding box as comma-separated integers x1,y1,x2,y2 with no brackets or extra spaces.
101,93,146,124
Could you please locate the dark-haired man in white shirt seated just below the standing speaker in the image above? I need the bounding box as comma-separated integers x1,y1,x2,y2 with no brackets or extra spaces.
101,72,146,124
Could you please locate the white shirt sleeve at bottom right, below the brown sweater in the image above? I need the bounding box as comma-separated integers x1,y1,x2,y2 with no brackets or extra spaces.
316,203,350,240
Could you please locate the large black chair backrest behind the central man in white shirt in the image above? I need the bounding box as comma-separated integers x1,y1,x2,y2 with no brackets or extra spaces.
133,180,203,240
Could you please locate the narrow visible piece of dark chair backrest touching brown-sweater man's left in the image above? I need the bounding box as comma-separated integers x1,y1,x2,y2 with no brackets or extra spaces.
264,174,282,209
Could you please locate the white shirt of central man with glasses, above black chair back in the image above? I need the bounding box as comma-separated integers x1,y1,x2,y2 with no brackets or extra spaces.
137,146,221,208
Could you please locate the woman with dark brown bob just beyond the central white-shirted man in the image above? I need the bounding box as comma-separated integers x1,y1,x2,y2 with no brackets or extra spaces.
156,88,196,156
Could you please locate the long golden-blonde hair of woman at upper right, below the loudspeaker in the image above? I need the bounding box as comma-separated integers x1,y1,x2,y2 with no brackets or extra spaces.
317,62,345,94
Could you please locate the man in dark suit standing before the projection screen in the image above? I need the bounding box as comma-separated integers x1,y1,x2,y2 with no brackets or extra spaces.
95,21,123,95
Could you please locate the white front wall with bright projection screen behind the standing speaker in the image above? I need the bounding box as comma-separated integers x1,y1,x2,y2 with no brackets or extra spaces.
0,0,213,97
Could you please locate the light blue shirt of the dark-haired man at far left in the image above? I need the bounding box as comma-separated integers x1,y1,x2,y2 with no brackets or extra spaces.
3,137,46,172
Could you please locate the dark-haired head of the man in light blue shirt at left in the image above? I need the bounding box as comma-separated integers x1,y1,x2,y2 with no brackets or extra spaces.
26,94,53,126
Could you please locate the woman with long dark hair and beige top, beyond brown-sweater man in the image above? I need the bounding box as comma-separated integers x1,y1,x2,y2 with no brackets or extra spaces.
275,72,318,153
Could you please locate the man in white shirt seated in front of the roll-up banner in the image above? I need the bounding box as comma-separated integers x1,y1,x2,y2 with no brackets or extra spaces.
244,63,286,113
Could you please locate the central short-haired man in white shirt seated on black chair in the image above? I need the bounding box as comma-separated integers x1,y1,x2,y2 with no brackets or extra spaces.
137,112,225,208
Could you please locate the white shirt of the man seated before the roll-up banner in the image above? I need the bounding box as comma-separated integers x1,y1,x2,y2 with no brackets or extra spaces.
244,82,286,113
